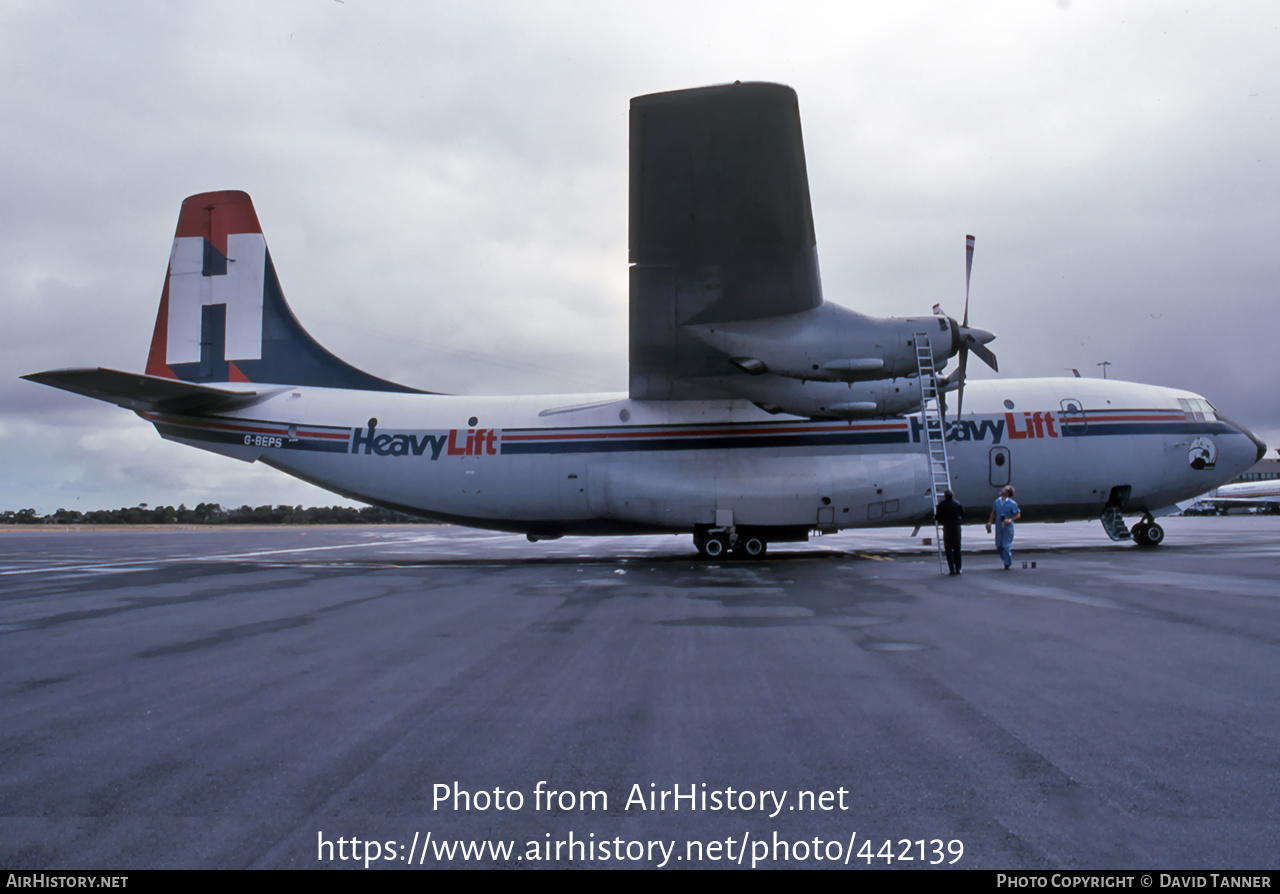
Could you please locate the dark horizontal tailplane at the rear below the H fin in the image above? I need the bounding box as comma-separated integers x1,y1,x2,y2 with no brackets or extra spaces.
22,366,267,414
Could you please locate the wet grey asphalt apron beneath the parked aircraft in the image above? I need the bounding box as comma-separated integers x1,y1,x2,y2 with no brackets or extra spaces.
0,516,1280,870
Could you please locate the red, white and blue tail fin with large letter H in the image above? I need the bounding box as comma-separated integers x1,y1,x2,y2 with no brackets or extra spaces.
147,191,419,392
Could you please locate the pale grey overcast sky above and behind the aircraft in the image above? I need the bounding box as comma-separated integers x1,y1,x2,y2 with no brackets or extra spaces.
0,0,1280,512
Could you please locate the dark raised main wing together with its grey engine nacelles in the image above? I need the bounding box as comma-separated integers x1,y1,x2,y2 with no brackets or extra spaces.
628,83,967,419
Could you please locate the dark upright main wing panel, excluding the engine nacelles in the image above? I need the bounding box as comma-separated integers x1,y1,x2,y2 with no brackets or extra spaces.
630,83,822,400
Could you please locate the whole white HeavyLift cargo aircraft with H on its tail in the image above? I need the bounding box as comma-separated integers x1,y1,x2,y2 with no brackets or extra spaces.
26,83,1263,556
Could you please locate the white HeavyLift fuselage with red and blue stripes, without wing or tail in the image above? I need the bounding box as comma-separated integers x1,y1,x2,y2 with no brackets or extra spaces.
142,379,1257,535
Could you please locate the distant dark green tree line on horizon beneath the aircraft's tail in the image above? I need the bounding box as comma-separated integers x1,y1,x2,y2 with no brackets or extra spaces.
0,503,428,525
